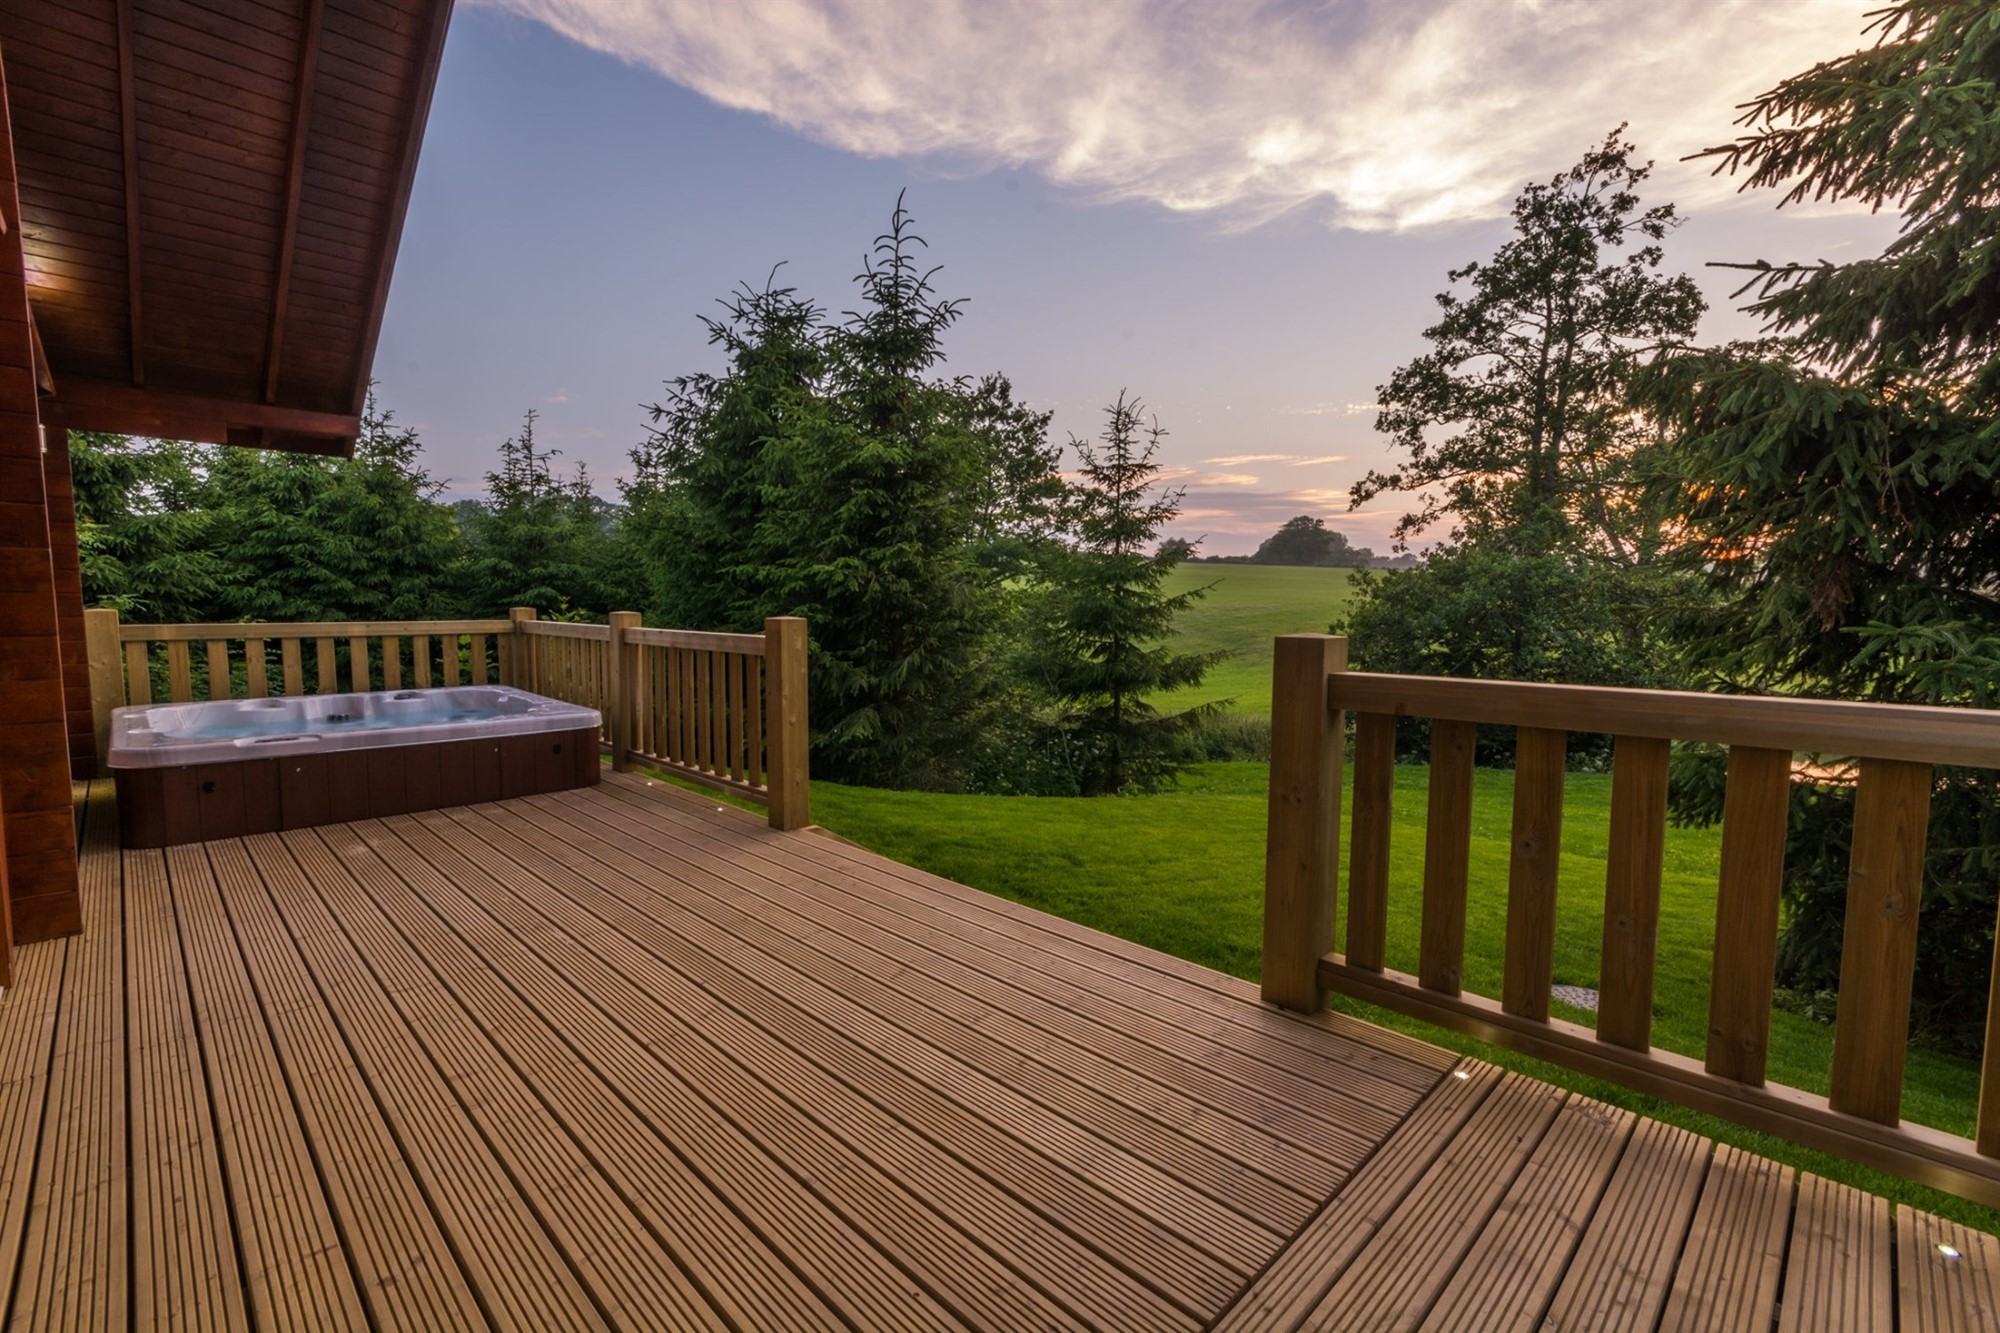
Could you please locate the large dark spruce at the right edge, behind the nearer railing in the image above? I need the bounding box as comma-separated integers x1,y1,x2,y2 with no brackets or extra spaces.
1640,0,2000,1047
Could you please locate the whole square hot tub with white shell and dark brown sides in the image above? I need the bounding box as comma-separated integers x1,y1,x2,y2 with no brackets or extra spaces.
110,685,600,847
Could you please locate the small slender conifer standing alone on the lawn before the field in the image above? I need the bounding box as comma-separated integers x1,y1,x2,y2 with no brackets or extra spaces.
1034,392,1226,797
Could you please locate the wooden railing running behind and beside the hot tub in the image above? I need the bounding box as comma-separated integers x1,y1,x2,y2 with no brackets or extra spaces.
84,608,810,829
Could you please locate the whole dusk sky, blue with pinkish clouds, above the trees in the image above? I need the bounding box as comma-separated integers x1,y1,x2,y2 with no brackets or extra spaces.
374,0,1894,554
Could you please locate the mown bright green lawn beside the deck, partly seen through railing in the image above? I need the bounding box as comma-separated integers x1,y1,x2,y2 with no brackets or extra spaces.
812,756,2000,1231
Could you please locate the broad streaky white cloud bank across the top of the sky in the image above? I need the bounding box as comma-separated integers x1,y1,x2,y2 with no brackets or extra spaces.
478,0,1870,230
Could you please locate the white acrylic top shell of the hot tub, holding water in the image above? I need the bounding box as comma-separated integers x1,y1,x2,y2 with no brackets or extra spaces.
108,685,602,769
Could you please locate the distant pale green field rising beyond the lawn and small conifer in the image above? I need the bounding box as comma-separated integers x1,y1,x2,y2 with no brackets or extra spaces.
1160,564,1354,717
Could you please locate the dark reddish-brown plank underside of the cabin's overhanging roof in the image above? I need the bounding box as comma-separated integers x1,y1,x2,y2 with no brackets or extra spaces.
0,0,450,452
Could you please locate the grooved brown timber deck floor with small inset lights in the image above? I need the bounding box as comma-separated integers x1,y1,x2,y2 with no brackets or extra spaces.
0,777,2000,1331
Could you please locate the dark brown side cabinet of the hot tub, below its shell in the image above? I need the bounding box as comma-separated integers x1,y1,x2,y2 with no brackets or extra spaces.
118,727,602,847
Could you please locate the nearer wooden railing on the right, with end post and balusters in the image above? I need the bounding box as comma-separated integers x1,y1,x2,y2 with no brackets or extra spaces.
1264,634,2000,1205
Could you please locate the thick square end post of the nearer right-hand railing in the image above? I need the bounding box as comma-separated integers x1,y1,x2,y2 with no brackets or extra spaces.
1264,634,1348,1013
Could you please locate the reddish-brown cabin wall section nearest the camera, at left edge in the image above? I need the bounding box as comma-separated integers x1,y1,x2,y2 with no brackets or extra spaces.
0,52,80,945
